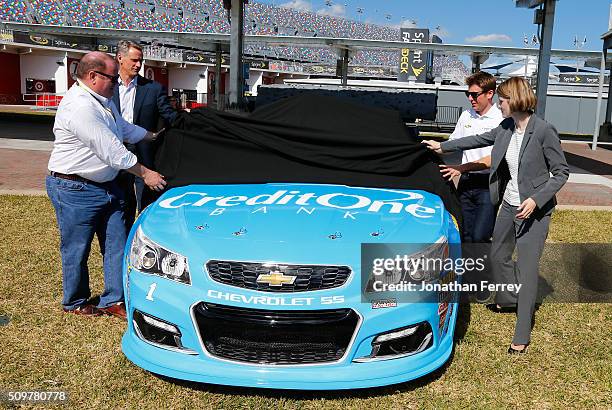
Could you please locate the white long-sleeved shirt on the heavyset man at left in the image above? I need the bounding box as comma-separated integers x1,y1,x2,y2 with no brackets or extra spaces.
49,83,147,182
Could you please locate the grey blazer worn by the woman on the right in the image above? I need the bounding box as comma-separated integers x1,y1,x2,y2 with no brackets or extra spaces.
441,114,569,214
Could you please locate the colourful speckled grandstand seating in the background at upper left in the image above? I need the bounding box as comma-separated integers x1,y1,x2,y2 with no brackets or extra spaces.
0,0,467,77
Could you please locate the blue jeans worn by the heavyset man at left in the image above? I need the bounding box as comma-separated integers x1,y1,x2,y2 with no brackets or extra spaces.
46,176,126,309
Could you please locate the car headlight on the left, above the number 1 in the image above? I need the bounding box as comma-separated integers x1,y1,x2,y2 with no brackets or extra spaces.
130,227,191,284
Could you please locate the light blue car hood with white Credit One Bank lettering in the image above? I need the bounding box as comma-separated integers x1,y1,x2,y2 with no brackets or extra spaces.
140,183,446,247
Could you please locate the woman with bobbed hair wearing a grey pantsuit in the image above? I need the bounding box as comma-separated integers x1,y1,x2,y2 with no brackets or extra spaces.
423,77,569,354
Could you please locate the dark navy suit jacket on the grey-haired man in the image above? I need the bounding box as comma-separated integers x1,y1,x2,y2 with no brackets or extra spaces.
113,75,176,168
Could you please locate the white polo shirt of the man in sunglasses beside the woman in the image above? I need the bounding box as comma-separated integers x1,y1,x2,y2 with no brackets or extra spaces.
448,104,504,173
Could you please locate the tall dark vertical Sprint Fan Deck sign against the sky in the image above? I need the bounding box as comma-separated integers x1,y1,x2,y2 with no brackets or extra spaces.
397,28,429,83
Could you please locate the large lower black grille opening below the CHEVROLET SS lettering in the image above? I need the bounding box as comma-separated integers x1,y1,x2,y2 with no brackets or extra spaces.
195,303,359,365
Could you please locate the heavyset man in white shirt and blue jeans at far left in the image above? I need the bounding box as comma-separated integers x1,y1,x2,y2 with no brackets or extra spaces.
46,52,166,318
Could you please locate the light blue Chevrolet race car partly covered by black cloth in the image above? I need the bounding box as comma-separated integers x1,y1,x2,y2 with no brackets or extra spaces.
122,183,460,390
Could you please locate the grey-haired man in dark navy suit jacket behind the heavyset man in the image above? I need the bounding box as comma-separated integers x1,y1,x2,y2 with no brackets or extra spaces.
113,40,176,230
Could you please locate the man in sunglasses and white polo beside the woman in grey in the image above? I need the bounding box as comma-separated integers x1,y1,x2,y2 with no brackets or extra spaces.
441,72,503,300
